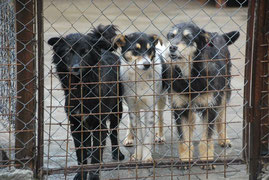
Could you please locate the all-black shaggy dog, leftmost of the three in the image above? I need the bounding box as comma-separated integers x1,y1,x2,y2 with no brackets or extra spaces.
48,25,124,180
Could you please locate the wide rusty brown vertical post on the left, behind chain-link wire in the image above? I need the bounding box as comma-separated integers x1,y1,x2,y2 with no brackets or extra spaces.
15,0,36,170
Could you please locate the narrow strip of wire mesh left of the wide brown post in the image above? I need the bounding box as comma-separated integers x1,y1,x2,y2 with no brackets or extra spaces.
0,1,17,168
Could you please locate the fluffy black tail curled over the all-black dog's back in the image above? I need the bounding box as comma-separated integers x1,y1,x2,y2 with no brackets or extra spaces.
87,24,118,51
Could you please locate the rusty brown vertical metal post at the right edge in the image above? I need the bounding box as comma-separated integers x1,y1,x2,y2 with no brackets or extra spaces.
246,0,267,180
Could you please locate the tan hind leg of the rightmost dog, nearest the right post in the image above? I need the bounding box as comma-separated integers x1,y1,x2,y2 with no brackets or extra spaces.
216,108,229,147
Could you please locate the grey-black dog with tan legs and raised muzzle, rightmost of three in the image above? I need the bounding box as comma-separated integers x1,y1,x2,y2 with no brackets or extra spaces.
166,23,239,168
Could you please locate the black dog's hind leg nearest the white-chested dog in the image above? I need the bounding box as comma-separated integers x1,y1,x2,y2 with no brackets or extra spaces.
110,102,124,160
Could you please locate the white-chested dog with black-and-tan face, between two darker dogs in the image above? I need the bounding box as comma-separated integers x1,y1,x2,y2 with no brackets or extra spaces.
114,32,166,162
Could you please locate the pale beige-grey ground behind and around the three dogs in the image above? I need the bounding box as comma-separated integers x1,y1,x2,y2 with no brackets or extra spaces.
44,0,247,179
